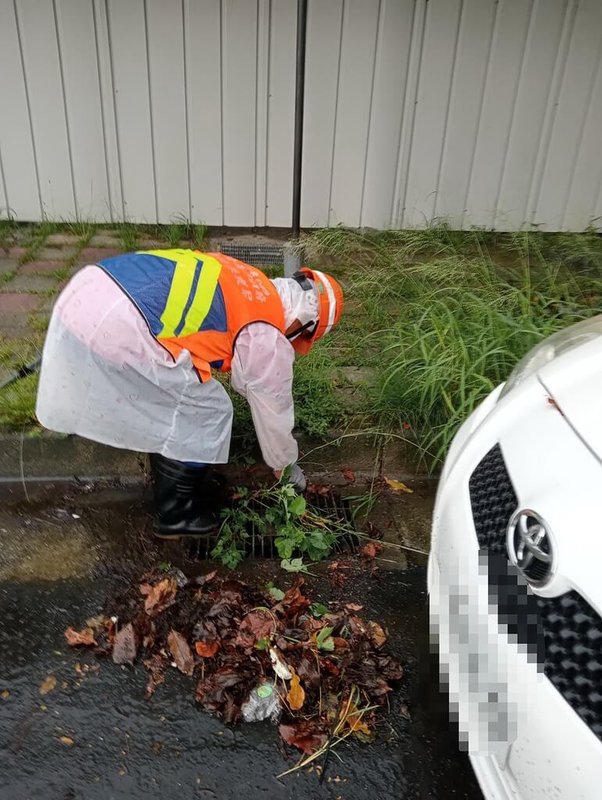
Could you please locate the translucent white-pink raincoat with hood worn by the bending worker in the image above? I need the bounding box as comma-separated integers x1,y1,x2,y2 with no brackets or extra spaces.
36,266,318,470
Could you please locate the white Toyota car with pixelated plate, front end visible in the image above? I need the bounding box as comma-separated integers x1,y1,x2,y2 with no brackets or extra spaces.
428,316,602,800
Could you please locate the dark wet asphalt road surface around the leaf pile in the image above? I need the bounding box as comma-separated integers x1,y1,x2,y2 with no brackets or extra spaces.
0,490,481,800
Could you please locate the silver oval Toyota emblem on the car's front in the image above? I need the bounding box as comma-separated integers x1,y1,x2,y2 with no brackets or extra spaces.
507,508,556,586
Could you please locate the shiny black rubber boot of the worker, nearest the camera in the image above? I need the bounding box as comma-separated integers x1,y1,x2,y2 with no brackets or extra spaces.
151,453,219,539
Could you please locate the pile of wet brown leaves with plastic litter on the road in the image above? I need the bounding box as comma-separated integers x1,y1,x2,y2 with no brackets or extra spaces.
65,571,402,758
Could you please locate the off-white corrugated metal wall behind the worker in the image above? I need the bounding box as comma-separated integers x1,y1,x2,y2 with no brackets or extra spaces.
0,0,602,230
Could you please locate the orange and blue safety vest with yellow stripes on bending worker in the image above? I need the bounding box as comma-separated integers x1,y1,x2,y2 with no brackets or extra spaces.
98,249,285,381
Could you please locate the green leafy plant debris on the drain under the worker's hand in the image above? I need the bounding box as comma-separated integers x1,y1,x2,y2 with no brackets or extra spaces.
212,484,352,572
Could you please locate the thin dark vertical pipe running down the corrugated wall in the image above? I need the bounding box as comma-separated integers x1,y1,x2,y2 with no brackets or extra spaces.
284,0,307,278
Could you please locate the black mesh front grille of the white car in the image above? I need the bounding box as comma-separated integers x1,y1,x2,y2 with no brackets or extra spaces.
469,445,602,739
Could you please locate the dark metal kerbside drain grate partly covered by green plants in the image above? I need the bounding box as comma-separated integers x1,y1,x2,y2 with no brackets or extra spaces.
188,492,359,561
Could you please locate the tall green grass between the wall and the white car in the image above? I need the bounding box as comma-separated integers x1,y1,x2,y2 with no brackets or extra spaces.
306,227,602,468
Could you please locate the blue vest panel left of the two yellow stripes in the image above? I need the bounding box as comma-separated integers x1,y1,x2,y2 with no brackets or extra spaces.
98,253,176,336
